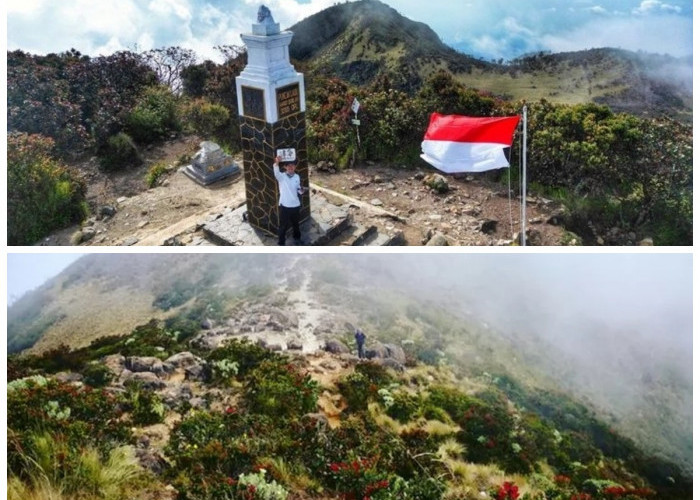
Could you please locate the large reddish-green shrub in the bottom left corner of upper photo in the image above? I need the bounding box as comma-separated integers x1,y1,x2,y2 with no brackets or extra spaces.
7,134,87,245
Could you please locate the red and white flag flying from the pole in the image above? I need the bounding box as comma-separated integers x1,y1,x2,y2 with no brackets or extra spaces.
421,113,520,174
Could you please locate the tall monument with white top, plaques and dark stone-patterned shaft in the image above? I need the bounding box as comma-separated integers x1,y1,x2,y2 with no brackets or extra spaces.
236,5,311,235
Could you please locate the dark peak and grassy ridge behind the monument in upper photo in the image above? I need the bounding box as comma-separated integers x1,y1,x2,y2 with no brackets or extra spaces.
290,0,692,121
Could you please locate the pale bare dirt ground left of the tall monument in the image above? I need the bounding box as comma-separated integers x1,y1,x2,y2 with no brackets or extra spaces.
40,136,245,246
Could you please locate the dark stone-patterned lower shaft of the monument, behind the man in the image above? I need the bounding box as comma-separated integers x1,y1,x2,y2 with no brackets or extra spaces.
241,113,311,235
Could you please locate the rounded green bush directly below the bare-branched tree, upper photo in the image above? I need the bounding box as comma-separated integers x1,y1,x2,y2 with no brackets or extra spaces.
126,87,180,144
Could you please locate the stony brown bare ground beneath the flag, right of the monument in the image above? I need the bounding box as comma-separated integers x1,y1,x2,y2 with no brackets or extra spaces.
311,165,569,245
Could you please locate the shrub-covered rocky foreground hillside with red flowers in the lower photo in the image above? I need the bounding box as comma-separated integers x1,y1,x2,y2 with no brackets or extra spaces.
8,313,692,500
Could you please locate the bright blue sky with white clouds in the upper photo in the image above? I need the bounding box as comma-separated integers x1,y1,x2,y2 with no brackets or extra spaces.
6,0,693,60
